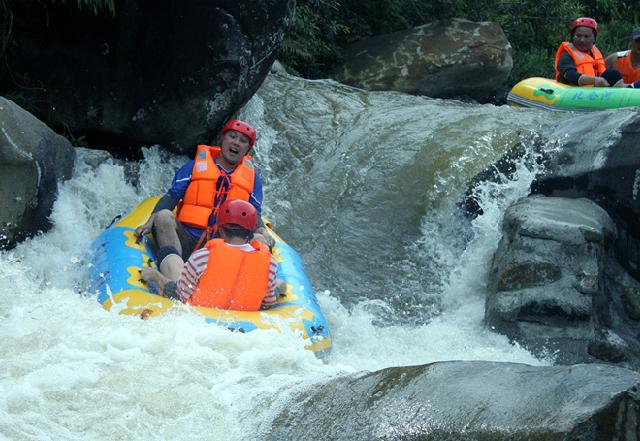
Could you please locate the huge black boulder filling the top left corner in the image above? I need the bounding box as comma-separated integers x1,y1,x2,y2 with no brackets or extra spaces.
0,0,295,152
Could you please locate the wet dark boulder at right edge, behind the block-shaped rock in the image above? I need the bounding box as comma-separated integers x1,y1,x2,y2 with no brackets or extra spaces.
532,109,640,280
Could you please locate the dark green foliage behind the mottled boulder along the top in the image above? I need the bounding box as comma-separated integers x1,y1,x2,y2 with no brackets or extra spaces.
281,0,640,84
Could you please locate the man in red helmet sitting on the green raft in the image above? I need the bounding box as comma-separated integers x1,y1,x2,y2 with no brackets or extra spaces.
555,17,625,87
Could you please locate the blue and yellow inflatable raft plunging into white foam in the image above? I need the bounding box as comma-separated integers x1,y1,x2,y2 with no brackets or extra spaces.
90,197,331,354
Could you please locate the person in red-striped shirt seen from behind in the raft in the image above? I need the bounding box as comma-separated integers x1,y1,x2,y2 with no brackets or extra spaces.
141,199,283,311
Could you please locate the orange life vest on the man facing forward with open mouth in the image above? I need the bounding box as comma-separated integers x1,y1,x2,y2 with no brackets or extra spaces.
177,145,255,228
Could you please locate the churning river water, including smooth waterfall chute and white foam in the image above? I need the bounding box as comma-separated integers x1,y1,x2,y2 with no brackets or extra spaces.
0,76,562,441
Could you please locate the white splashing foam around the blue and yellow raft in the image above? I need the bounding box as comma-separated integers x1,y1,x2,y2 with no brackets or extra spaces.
0,86,564,441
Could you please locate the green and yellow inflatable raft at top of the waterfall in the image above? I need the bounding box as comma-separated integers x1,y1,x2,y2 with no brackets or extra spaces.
507,77,640,112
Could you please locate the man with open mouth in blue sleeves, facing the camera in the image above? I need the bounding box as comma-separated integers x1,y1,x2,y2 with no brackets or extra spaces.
134,120,273,278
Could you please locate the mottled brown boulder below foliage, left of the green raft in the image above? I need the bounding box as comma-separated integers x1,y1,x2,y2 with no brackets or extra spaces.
335,18,513,101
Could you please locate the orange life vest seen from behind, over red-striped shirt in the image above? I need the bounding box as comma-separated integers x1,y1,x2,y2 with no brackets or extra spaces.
187,239,271,311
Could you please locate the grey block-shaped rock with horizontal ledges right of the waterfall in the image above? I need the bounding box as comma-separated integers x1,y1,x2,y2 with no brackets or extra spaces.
485,196,640,368
